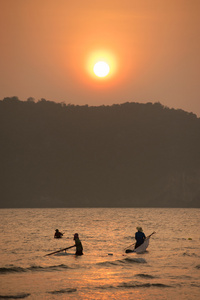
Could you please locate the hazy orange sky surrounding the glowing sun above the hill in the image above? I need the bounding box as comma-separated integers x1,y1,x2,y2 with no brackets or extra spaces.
0,0,200,116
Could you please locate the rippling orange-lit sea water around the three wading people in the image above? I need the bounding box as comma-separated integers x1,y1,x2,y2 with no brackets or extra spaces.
0,208,200,300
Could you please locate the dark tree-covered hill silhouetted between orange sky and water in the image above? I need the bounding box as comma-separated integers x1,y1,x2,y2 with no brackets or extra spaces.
0,97,200,207
